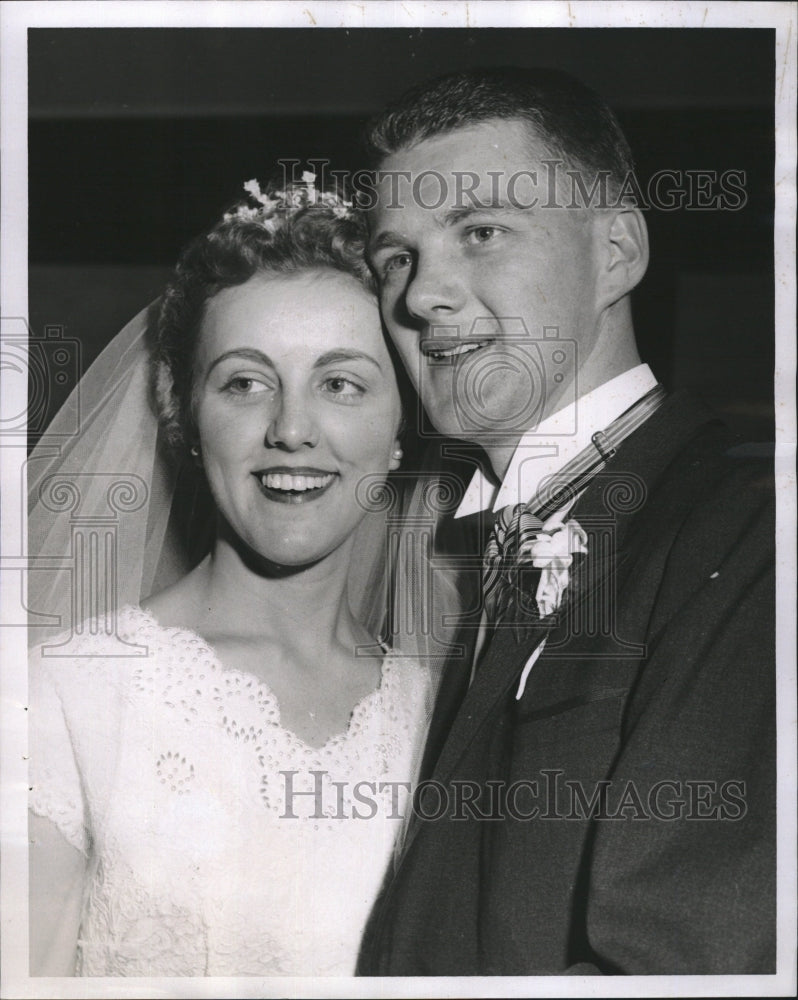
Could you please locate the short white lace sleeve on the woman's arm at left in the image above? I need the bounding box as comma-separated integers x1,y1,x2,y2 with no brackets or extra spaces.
28,647,89,854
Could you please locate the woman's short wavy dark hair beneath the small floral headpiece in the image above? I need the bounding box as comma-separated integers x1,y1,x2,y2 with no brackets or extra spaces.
152,199,376,451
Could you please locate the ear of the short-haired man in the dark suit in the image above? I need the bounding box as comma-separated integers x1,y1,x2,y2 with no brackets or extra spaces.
597,207,648,307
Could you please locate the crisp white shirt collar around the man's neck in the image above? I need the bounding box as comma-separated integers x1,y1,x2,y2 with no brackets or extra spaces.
454,365,657,518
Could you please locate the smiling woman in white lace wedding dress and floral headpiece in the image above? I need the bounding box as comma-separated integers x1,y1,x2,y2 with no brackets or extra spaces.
30,182,438,976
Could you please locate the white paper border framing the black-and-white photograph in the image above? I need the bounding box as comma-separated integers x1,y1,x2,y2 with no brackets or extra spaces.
0,0,797,997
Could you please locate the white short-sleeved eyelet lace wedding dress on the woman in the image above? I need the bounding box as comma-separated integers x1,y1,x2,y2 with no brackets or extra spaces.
30,607,430,976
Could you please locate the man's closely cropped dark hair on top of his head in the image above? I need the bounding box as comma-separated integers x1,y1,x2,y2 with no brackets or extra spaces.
365,67,634,194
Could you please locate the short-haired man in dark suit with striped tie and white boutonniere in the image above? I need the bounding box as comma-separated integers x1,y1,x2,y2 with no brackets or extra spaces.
359,70,775,976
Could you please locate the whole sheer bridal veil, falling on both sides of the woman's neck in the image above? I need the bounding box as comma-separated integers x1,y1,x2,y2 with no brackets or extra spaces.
27,303,460,677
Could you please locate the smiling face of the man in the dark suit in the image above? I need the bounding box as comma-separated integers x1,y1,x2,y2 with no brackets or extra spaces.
369,120,598,458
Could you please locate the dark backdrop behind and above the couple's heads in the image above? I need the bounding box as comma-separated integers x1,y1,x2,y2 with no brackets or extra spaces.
28,28,775,441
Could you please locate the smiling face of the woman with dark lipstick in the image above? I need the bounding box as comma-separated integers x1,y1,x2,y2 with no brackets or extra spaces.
193,270,401,566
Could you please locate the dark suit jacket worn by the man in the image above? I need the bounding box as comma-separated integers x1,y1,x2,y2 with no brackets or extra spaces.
359,395,775,975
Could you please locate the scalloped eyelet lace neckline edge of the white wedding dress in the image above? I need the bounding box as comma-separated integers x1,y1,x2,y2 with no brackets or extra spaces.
126,604,396,753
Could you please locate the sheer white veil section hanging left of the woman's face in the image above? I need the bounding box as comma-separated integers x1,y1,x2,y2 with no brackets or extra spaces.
28,307,173,641
